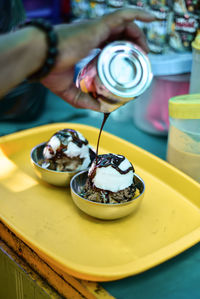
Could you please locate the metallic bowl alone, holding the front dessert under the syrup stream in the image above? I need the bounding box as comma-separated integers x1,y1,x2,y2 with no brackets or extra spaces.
70,170,145,220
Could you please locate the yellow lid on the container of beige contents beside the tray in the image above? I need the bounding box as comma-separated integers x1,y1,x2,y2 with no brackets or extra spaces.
169,94,200,119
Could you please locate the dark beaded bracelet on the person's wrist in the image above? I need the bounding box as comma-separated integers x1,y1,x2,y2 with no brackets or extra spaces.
19,19,58,81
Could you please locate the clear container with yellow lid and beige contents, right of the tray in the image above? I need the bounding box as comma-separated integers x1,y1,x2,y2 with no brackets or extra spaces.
167,94,200,183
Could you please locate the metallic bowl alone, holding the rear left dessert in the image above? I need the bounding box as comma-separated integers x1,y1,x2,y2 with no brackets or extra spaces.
31,142,77,187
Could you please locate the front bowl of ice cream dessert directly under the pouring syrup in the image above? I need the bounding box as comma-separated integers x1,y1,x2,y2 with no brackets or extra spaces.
70,154,145,220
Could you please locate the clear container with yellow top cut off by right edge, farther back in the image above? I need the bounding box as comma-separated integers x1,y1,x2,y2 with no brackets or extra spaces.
190,32,200,93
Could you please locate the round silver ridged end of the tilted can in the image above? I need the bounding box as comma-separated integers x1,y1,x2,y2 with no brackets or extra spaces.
97,41,153,98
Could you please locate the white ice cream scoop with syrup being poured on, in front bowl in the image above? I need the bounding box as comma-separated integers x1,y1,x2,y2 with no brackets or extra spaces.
88,154,134,192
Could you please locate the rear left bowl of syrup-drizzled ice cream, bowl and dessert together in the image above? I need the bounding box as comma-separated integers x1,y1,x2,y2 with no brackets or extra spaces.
31,129,95,186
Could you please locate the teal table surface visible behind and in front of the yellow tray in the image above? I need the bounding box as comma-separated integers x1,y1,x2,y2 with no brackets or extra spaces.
0,93,200,299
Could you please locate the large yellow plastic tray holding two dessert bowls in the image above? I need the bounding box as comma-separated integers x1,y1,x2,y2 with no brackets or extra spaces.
0,123,200,281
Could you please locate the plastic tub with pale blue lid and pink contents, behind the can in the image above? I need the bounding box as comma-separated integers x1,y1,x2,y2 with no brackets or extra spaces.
132,52,192,136
